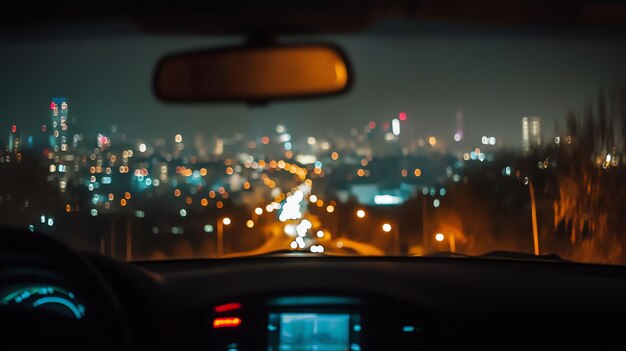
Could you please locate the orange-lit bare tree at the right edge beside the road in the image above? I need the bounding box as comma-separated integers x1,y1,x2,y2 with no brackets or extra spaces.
545,86,626,263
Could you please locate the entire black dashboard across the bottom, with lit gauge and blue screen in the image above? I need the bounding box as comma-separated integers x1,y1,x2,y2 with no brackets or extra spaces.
0,236,626,351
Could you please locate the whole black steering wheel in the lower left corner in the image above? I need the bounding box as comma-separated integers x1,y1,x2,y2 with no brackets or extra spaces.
0,228,131,350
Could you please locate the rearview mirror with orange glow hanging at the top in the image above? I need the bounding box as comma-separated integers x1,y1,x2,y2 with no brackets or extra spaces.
154,45,350,102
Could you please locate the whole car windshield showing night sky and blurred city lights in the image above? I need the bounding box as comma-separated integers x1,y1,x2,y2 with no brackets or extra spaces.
0,21,626,264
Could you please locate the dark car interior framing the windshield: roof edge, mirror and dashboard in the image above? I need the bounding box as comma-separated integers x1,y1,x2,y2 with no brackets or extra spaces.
0,0,626,351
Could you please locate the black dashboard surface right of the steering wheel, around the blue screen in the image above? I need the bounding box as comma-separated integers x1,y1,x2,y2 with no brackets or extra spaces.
89,256,626,351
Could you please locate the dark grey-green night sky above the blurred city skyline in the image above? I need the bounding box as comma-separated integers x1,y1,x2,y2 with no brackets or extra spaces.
0,23,626,148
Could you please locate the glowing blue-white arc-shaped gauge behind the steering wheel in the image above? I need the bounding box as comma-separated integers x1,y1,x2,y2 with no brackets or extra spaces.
0,285,85,319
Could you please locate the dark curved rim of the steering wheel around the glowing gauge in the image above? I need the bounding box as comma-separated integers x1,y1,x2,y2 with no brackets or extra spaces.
0,228,131,350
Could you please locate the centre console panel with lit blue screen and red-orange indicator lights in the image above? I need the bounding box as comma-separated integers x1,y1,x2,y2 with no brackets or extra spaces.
200,295,427,351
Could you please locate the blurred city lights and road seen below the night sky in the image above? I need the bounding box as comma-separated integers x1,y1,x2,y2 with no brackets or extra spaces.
0,88,626,263
